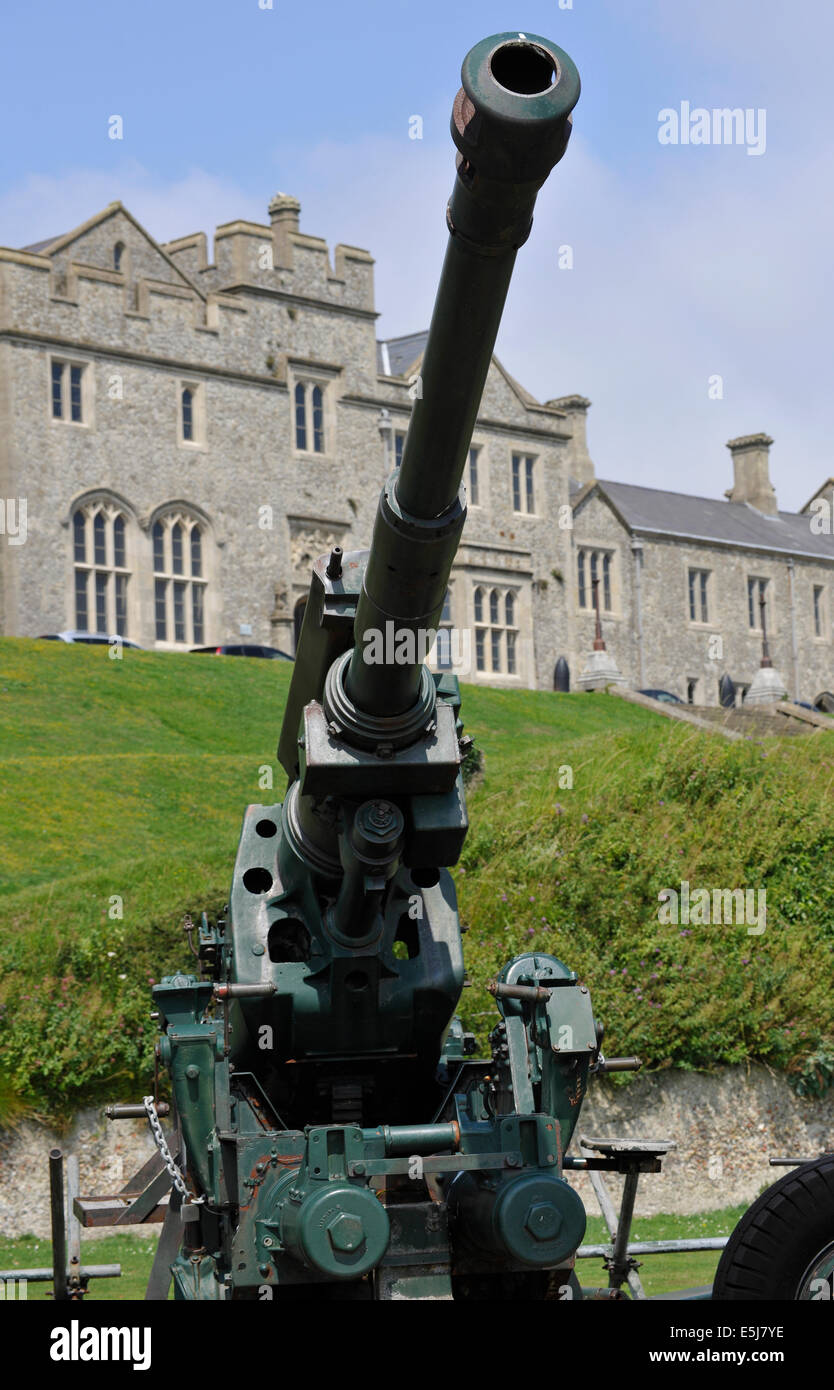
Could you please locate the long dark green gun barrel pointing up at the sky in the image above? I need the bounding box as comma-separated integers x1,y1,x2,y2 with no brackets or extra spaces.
346,33,580,716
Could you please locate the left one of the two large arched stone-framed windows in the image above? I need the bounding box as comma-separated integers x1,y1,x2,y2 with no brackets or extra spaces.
67,488,140,638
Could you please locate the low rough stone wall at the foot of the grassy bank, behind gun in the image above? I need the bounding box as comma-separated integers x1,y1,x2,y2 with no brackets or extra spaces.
0,1066,834,1236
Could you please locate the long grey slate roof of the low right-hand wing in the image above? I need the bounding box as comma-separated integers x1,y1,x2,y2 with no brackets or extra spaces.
582,480,834,560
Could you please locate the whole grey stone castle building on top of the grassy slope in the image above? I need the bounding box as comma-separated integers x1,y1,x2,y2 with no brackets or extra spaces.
0,193,834,703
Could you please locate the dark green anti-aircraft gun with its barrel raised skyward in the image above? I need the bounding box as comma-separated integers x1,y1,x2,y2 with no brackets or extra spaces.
153,33,642,1300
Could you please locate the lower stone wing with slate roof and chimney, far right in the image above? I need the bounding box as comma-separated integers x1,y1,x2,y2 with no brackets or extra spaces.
571,419,834,705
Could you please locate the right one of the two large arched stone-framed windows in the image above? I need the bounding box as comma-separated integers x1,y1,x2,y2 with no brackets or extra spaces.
147,502,214,652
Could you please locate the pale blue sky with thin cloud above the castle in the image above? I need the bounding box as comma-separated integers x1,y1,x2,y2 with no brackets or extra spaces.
0,0,834,509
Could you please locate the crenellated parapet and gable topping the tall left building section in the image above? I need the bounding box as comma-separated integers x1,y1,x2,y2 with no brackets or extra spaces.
0,191,375,389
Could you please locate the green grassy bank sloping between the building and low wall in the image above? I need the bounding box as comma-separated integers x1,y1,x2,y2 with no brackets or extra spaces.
0,639,834,1115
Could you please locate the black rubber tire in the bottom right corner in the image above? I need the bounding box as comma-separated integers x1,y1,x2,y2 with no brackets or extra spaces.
713,1154,834,1302
